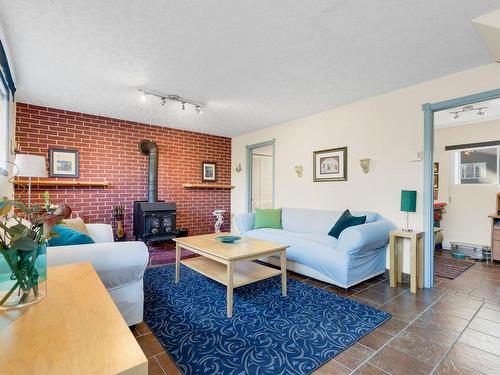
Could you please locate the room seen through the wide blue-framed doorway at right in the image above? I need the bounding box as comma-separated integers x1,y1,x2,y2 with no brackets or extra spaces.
433,99,500,279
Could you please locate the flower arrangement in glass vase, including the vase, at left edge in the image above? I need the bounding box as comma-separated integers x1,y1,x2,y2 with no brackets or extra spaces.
0,192,71,309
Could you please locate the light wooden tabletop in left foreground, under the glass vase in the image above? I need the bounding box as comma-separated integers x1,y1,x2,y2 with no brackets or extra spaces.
0,263,148,375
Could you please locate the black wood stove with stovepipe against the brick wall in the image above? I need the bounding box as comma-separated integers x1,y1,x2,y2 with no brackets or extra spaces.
134,140,177,242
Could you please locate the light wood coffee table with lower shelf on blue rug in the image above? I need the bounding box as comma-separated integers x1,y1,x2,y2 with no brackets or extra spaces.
174,233,288,318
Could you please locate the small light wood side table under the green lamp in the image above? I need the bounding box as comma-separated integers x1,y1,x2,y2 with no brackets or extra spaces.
389,229,424,293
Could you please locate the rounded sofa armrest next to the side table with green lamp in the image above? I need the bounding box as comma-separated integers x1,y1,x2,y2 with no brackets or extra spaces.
337,220,395,253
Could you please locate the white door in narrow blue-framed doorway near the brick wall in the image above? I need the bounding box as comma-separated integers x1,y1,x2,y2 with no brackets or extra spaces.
247,140,275,212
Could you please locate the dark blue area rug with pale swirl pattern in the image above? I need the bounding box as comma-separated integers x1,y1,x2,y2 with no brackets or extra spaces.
144,265,390,375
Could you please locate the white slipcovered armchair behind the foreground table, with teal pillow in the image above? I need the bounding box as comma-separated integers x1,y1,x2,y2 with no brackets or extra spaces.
47,224,149,326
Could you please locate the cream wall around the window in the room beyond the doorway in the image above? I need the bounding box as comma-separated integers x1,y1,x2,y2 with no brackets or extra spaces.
434,120,500,248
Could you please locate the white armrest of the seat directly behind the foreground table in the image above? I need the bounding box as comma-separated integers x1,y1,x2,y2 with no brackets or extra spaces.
47,241,149,289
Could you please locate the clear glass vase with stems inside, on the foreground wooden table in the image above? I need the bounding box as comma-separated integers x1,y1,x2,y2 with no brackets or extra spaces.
0,245,47,310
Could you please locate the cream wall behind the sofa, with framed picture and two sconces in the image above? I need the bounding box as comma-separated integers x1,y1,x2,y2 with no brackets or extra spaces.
231,64,500,272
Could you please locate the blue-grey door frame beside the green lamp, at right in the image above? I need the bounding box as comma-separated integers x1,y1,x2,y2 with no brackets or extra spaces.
422,89,500,288
